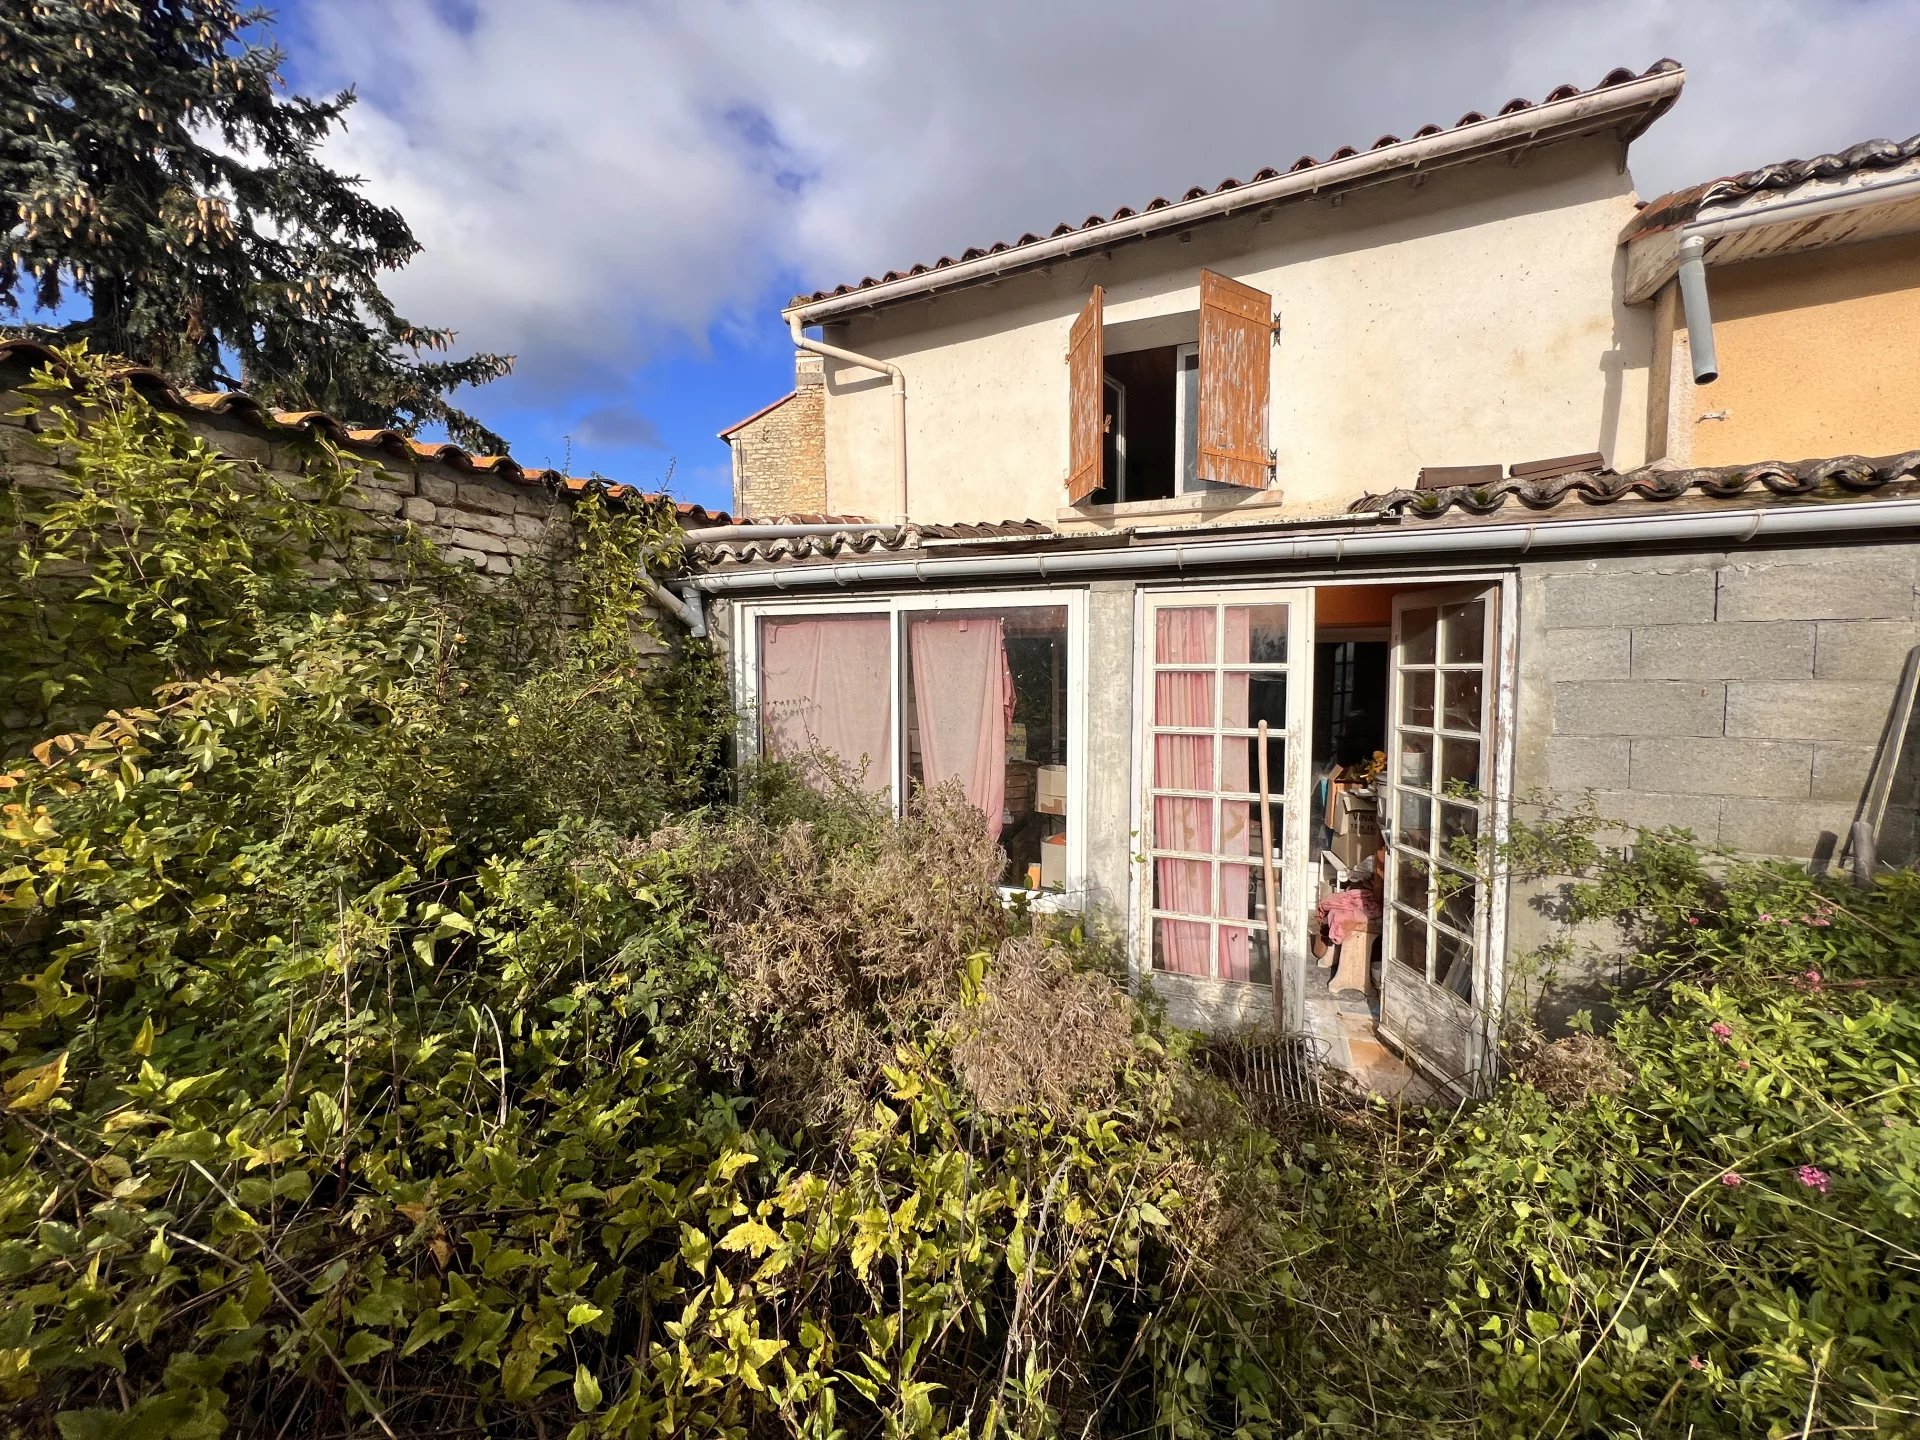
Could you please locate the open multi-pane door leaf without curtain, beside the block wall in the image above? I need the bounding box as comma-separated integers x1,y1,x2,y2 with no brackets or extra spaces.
1379,586,1500,1091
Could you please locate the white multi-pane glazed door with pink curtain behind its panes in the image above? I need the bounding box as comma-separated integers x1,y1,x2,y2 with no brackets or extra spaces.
1139,588,1313,1029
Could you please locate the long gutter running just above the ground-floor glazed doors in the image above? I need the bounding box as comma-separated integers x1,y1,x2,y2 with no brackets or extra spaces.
693,499,1920,595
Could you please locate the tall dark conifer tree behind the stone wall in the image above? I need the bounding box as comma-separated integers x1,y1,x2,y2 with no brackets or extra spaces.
0,0,513,451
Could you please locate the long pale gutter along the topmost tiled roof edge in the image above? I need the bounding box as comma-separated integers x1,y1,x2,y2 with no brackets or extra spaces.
785,67,1686,326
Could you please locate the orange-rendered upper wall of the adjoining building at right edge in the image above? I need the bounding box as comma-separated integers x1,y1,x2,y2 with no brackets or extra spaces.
1655,234,1920,465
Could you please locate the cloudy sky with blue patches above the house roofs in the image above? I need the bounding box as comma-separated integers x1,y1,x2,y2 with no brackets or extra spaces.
301,0,1920,401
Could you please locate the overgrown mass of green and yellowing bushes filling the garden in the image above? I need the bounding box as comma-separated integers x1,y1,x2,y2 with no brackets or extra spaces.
0,353,1920,1440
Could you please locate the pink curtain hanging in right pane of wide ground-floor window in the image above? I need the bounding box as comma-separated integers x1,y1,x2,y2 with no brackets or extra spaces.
906,616,1014,839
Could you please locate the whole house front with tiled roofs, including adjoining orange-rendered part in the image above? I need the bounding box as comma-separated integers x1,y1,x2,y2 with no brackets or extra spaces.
693,61,1920,1085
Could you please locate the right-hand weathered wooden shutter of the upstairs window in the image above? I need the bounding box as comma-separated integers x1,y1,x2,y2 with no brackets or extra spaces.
1196,271,1273,490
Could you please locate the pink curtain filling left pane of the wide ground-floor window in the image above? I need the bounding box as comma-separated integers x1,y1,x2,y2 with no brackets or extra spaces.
760,614,893,795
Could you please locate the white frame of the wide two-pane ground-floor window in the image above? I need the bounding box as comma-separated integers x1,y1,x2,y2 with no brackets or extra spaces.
732,588,1089,910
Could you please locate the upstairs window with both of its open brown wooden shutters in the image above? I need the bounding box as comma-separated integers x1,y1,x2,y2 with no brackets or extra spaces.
1068,271,1273,505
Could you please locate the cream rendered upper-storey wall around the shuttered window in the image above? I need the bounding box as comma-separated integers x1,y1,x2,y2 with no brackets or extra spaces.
810,140,1651,520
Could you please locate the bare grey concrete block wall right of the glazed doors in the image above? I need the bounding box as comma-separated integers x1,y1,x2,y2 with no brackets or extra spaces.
1515,545,1920,860
